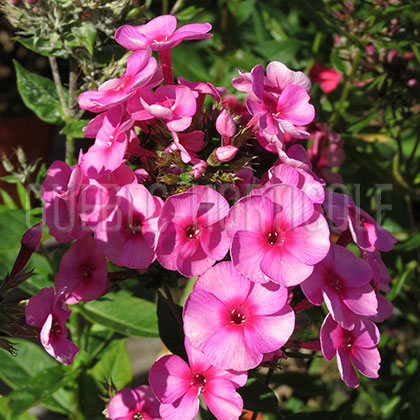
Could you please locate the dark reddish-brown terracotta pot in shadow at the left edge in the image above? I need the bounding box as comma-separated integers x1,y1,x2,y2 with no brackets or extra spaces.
0,114,56,203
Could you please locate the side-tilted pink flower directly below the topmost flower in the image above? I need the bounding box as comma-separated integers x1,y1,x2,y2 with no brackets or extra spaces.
78,49,162,112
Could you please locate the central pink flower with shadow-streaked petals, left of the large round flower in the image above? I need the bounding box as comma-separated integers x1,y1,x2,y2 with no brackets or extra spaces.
156,185,229,277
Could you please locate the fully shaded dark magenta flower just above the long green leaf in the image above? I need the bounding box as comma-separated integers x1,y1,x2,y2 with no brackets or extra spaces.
55,236,108,304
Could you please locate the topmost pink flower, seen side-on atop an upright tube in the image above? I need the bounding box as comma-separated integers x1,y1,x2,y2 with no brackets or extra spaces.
115,15,213,51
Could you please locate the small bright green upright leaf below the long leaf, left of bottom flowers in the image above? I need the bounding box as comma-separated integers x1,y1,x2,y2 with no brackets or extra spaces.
89,338,132,392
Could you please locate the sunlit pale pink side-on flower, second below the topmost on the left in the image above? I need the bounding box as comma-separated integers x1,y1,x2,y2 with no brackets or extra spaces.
80,105,133,178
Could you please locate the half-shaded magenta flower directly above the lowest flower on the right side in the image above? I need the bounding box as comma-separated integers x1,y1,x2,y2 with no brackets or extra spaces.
300,244,378,330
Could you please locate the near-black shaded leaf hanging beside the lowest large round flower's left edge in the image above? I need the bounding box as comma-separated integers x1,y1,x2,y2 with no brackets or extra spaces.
157,292,188,361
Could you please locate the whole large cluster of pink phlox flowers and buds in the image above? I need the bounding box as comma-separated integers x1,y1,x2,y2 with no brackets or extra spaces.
27,16,395,420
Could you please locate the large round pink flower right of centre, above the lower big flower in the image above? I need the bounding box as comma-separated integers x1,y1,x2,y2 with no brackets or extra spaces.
226,185,330,286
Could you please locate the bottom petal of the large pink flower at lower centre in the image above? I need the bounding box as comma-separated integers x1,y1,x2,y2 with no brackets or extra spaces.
203,324,262,370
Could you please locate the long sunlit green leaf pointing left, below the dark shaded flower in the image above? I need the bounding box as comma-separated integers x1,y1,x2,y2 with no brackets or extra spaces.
79,292,159,337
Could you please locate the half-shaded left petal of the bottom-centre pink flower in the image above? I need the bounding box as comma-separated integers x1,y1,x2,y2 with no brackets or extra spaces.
149,354,192,404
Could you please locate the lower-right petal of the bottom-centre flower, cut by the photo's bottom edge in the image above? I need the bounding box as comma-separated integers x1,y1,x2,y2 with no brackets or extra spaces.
203,378,243,420
